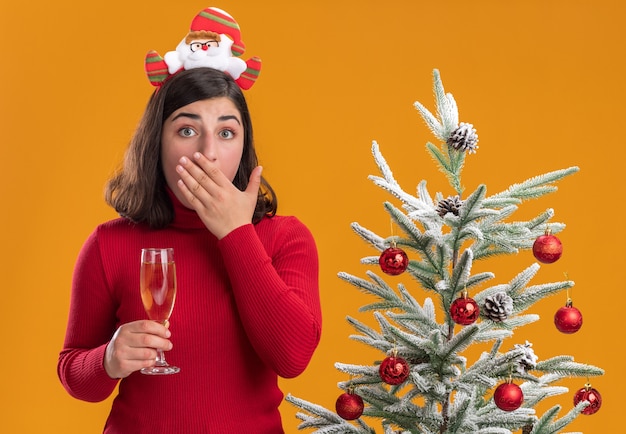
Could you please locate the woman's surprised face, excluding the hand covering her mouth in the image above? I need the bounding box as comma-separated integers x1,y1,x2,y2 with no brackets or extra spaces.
161,97,244,206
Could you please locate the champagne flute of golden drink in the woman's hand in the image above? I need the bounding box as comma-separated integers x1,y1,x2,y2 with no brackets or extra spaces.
140,248,180,375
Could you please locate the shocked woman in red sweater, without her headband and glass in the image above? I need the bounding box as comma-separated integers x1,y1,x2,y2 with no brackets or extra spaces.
57,67,321,434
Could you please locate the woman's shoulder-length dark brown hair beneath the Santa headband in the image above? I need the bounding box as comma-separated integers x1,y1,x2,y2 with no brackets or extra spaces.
105,68,277,228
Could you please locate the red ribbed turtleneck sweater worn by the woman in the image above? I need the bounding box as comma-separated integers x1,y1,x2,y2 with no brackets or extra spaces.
57,195,321,434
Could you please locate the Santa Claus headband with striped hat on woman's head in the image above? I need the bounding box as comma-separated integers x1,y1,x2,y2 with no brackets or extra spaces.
145,7,261,89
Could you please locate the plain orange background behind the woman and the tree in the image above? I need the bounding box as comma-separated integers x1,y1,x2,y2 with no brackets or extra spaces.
0,0,626,434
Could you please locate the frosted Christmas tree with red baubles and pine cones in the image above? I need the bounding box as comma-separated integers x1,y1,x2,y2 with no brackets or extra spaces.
286,70,604,434
